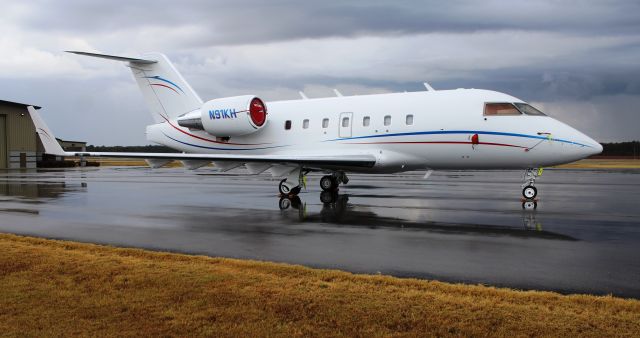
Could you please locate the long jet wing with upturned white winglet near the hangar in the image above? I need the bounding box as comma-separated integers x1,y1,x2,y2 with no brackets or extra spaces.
28,106,376,172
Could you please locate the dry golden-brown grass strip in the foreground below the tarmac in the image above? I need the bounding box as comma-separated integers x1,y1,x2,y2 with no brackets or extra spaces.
0,234,640,337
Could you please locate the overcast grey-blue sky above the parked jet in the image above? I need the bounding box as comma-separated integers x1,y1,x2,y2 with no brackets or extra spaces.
0,0,640,145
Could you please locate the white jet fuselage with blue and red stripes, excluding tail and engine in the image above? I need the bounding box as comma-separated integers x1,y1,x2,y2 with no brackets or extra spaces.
147,89,602,172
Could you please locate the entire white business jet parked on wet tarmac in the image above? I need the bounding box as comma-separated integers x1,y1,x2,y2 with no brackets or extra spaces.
29,51,602,200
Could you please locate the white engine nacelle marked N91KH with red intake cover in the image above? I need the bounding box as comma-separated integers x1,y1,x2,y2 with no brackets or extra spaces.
178,95,267,137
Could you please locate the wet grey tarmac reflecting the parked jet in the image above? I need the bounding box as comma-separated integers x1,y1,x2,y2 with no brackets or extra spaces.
0,168,640,298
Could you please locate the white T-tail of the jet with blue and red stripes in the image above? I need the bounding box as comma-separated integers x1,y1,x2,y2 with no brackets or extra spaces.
68,51,202,122
